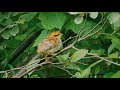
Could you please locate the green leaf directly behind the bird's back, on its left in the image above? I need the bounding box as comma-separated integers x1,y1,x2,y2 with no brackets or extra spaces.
33,30,51,47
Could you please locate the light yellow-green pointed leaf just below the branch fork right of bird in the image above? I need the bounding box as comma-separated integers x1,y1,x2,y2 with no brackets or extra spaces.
70,49,88,62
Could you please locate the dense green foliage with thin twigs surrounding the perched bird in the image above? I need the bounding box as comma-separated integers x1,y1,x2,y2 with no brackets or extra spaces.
0,12,120,78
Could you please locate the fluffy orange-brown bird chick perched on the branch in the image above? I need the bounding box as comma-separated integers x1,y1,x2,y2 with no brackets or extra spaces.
37,31,62,56
